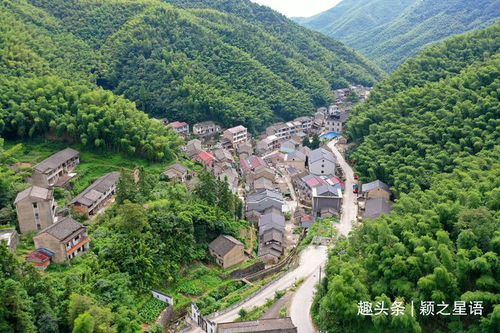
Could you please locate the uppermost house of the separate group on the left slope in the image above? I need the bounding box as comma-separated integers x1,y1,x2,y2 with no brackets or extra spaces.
30,148,80,187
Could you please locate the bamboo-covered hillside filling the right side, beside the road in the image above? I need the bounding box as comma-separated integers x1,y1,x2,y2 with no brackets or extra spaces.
313,25,500,332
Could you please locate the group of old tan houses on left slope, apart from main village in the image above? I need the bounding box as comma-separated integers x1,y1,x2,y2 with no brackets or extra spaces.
5,148,120,270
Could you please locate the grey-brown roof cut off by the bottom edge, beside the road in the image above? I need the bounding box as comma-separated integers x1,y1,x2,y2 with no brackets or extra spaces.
217,317,297,333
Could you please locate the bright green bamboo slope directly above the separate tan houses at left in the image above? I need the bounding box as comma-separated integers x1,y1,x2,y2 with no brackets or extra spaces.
0,1,182,161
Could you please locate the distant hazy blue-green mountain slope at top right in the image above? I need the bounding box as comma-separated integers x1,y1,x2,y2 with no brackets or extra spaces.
296,0,500,71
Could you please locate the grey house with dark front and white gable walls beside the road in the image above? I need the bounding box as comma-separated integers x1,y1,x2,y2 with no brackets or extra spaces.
312,184,342,219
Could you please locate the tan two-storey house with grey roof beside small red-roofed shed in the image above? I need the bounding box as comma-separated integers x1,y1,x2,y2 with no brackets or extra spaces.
33,216,89,263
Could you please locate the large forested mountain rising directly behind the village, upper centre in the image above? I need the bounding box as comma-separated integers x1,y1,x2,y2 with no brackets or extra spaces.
24,0,381,130
